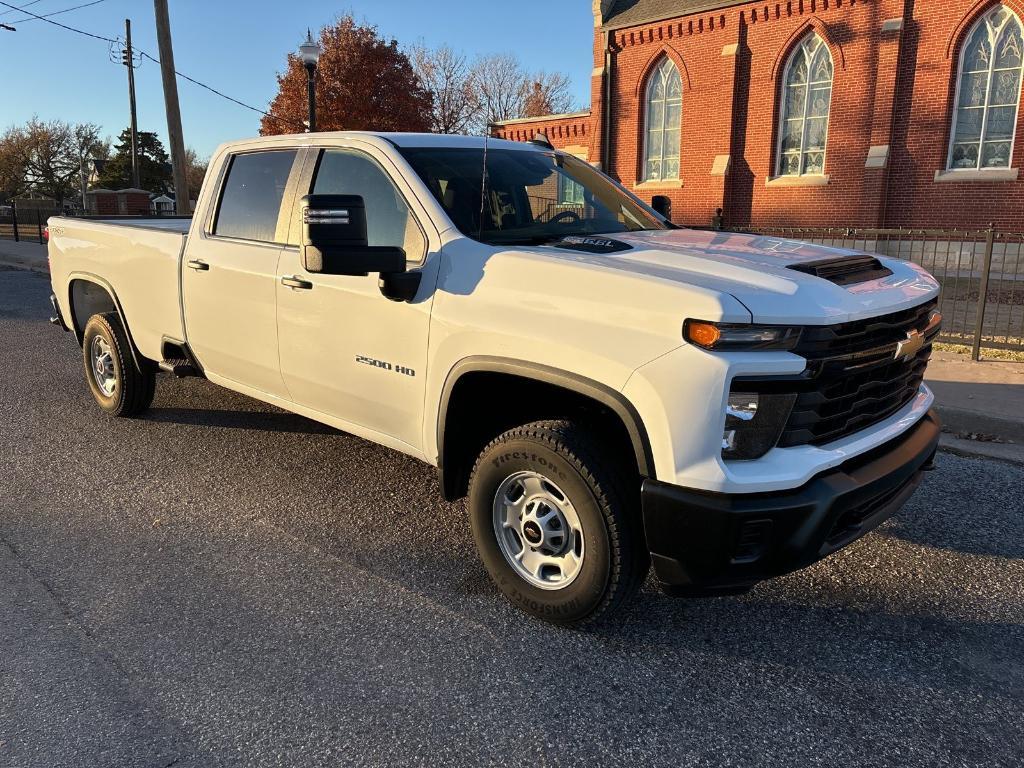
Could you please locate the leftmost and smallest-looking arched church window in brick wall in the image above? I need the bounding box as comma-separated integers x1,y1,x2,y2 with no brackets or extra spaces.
643,58,683,181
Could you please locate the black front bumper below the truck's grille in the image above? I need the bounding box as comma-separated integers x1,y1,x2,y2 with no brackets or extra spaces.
641,411,940,594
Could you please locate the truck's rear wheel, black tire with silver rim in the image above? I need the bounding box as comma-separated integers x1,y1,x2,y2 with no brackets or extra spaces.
82,312,157,417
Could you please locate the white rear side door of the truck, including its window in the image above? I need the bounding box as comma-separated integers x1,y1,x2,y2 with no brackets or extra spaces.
181,150,301,397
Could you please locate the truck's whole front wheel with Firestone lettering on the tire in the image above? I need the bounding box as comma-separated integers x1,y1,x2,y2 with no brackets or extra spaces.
469,421,648,625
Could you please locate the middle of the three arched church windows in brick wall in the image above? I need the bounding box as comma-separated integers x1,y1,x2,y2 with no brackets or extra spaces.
776,34,833,176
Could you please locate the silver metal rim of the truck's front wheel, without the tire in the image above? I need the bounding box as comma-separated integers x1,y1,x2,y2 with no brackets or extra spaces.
494,472,584,590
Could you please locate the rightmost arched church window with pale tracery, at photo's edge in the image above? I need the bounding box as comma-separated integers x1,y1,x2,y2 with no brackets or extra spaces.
947,5,1024,170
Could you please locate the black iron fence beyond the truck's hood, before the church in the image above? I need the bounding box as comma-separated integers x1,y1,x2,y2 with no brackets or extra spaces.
746,227,1024,359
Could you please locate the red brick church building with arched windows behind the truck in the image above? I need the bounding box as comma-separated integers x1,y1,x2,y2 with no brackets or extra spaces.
493,0,1024,231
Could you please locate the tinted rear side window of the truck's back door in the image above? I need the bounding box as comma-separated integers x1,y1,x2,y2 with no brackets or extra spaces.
213,150,296,243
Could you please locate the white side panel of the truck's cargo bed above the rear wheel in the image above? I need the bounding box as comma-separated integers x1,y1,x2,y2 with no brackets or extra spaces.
49,216,191,359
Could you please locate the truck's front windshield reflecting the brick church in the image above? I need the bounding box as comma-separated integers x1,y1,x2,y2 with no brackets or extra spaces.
400,146,668,245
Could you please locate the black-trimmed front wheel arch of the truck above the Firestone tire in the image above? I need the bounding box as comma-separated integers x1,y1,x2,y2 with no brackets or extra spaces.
437,356,654,501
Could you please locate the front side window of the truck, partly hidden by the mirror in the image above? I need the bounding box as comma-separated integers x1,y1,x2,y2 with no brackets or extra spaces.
312,150,427,262
